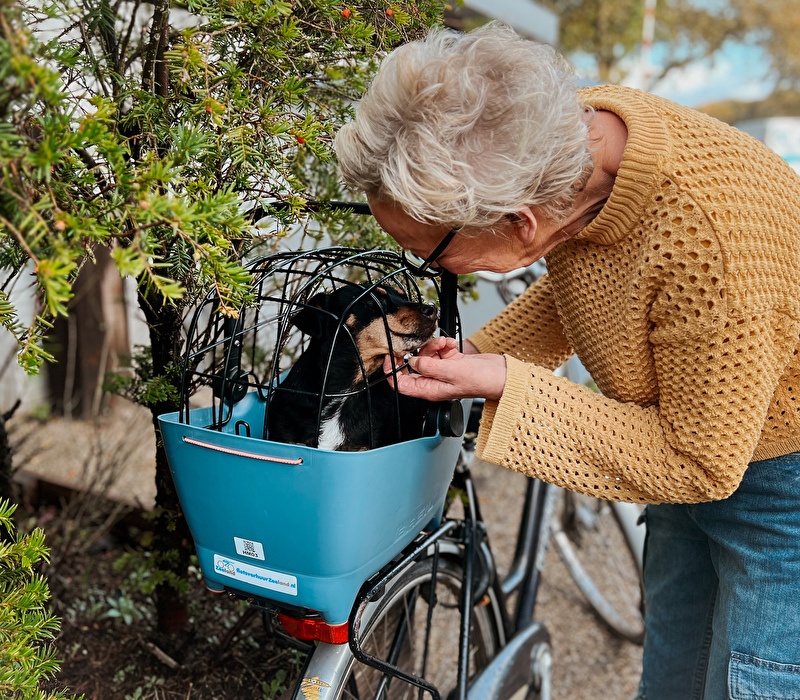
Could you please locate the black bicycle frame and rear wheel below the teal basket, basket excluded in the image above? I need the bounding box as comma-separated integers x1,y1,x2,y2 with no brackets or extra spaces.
291,408,555,700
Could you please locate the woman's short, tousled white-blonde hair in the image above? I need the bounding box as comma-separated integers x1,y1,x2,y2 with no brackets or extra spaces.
335,22,592,227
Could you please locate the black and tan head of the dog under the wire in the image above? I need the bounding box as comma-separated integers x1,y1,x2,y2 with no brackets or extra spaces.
292,285,439,374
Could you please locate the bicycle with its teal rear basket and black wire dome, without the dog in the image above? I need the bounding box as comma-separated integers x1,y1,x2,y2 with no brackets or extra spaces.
160,238,556,700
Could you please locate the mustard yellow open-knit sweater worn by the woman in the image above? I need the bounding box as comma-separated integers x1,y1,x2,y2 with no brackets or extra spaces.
470,86,800,503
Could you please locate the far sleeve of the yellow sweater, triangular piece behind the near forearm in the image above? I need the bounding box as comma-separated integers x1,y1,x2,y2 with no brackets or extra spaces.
469,275,572,369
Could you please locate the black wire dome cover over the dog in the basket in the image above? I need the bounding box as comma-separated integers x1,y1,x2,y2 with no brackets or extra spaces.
180,247,457,449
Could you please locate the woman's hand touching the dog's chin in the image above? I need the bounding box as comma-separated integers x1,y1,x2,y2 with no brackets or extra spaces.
383,338,506,401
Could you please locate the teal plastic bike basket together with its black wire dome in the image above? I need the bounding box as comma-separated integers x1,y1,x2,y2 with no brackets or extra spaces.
159,247,461,624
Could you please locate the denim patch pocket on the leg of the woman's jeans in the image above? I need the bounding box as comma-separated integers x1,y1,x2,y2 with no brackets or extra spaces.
728,651,800,700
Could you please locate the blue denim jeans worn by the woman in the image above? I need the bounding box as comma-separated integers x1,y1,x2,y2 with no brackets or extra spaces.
638,453,800,700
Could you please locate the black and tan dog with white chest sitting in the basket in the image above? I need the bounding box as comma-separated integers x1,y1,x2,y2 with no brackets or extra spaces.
266,284,439,451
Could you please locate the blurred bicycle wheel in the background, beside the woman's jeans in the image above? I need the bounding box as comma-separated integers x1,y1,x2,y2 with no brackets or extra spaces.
552,491,644,644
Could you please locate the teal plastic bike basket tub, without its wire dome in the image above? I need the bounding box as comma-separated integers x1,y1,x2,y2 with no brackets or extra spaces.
159,392,461,624
